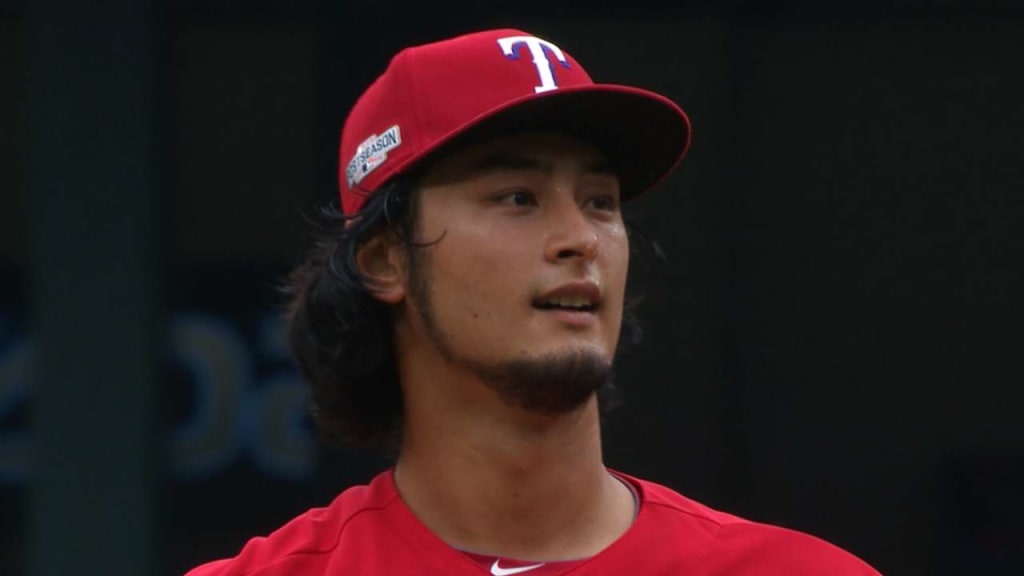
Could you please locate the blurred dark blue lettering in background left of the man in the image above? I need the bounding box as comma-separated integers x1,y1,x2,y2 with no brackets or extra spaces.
0,266,317,486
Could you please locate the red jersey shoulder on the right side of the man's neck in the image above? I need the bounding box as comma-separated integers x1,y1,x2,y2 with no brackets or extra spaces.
614,477,879,576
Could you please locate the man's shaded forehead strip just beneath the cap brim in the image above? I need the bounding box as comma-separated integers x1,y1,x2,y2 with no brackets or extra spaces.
421,133,614,184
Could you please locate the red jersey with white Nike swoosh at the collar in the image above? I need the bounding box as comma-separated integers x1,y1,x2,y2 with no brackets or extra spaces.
186,470,879,576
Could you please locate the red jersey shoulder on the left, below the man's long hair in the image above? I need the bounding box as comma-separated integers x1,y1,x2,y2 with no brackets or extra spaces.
185,471,397,576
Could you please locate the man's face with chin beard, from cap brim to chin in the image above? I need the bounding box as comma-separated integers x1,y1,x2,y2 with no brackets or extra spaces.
404,135,629,413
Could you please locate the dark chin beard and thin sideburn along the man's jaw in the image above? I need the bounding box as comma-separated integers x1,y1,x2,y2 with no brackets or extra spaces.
408,248,613,416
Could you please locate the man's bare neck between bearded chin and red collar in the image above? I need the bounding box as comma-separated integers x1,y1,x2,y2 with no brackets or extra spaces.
395,384,635,561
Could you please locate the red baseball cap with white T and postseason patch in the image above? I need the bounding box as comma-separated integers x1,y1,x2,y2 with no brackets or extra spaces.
339,29,690,214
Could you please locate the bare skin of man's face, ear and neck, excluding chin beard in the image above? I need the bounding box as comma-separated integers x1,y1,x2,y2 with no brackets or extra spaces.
358,134,635,561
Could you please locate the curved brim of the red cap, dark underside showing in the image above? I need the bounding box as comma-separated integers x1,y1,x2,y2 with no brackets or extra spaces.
399,84,690,198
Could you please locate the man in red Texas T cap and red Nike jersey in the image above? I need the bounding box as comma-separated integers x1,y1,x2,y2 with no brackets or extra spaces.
189,30,877,576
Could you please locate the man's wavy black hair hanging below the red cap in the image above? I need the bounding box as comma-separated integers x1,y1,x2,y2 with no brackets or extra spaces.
286,176,657,451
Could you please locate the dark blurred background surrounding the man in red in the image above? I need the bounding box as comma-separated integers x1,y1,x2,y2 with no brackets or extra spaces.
0,0,1024,576
